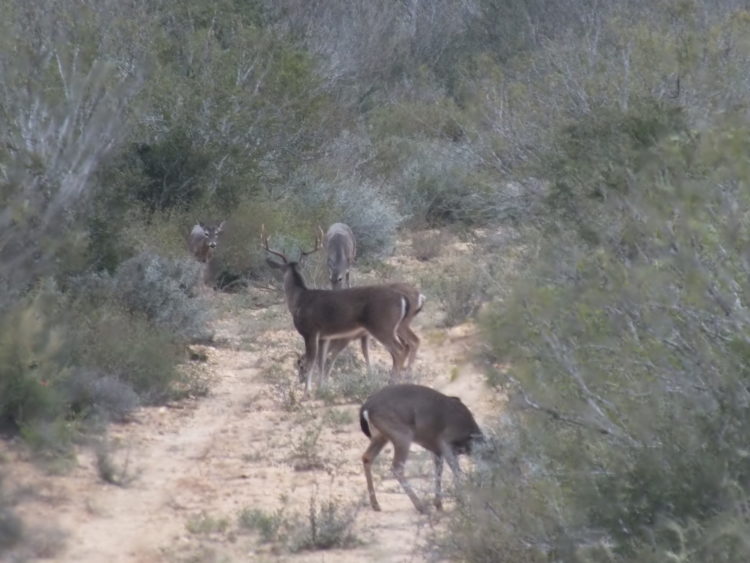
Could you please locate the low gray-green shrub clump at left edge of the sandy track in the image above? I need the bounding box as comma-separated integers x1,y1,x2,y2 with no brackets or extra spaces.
0,275,194,451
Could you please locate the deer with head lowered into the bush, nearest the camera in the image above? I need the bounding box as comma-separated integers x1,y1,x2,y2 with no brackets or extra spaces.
359,383,484,514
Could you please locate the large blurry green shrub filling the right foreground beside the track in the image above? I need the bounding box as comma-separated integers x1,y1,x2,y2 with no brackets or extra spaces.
451,121,750,561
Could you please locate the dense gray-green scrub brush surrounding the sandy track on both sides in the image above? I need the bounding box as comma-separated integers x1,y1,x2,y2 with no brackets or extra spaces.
0,0,750,562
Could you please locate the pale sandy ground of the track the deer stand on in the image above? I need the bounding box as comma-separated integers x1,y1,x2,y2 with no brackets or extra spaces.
0,237,506,563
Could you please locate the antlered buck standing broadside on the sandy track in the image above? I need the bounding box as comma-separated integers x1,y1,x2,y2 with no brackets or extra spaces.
261,227,409,395
